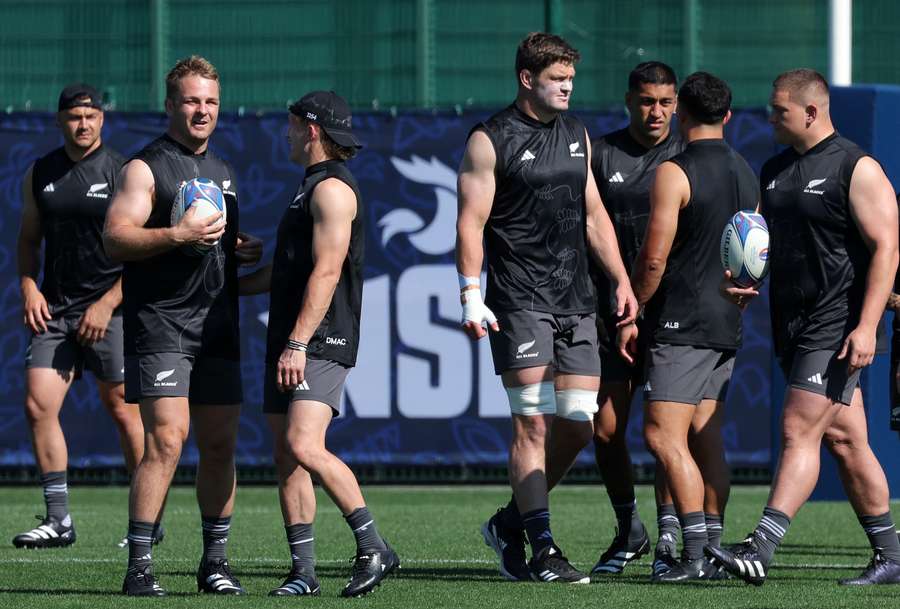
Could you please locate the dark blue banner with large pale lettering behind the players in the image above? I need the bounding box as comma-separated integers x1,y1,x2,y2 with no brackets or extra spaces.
0,110,776,467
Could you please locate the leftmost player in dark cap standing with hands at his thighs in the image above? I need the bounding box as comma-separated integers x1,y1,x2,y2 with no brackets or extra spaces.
13,84,152,548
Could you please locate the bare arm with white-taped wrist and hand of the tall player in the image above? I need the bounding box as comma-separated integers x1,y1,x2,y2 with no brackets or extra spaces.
456,131,500,339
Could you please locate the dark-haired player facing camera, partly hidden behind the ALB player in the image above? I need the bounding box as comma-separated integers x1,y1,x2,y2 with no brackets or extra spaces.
591,61,684,573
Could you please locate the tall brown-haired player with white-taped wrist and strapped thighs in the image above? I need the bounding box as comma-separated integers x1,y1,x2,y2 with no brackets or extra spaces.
456,33,636,583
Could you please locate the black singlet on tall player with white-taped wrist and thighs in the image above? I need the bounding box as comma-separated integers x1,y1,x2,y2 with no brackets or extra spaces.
473,104,596,315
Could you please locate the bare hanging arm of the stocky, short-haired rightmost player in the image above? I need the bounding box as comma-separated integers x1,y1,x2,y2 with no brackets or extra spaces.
838,157,898,371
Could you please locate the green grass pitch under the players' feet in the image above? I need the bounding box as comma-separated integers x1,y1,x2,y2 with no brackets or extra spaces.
0,486,900,609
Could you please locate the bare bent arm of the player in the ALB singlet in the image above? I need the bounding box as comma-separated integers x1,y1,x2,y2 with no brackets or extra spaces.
631,161,691,306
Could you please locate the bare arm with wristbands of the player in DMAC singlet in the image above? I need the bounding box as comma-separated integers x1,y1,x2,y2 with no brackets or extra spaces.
276,178,356,391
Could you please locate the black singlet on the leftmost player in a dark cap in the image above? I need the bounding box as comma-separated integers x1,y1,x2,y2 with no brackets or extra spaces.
31,146,124,317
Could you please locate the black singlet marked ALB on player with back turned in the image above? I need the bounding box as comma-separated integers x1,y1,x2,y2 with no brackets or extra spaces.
646,139,759,349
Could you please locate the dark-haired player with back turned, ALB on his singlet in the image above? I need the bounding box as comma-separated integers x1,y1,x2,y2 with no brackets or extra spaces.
632,72,759,583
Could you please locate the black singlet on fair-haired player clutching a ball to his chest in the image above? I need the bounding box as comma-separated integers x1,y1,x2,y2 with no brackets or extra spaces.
122,135,240,360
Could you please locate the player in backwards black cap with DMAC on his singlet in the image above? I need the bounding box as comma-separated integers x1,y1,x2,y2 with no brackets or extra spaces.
241,91,400,597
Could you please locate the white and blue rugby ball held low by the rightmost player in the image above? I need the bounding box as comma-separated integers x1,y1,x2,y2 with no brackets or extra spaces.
720,211,769,288
